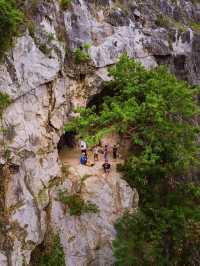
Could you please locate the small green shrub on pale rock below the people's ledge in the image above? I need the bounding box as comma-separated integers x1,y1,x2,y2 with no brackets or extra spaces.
59,191,99,216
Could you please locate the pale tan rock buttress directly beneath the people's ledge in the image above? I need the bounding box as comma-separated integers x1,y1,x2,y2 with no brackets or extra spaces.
52,166,138,266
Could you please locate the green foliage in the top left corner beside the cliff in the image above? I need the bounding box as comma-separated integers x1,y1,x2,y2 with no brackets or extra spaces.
0,0,23,59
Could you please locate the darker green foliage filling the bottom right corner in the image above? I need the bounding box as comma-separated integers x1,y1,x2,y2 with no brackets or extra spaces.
113,184,200,266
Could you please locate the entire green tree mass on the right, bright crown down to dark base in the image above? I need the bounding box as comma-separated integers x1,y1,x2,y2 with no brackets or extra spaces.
66,55,200,266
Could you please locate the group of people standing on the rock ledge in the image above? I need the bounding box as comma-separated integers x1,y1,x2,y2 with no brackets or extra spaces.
80,140,118,175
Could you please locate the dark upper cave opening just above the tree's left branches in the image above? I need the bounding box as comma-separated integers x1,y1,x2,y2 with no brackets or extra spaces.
87,83,116,113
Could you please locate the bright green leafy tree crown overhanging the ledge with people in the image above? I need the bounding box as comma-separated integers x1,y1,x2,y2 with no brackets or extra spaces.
65,55,199,181
